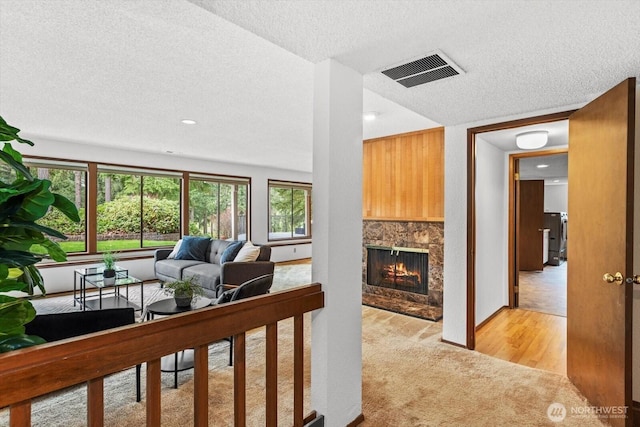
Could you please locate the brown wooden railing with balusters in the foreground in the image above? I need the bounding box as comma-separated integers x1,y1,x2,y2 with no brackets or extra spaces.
0,283,324,427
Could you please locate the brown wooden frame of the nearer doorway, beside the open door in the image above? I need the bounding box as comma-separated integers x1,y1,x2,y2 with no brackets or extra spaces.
466,110,576,350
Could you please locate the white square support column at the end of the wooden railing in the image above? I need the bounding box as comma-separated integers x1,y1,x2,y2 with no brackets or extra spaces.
311,59,362,427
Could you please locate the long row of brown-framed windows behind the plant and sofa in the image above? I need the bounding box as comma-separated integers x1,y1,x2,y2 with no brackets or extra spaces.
19,157,251,254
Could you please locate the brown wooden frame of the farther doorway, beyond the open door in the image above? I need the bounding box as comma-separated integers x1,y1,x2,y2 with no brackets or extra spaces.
508,147,569,308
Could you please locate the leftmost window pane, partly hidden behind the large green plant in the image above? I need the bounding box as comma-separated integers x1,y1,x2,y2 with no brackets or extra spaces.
24,160,87,254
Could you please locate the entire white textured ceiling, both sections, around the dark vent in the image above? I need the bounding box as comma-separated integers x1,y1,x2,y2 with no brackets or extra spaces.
0,0,640,171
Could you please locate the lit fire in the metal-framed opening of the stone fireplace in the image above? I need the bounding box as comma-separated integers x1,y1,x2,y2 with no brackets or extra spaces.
367,245,429,295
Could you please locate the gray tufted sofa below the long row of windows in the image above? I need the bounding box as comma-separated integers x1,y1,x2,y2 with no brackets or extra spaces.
154,239,275,297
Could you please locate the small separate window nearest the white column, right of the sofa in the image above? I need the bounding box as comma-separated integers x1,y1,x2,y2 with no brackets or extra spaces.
269,181,311,240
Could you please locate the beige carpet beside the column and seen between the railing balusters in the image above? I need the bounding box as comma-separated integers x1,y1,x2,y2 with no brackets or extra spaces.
0,266,603,427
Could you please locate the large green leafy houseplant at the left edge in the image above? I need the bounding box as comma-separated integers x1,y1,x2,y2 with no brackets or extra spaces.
0,116,80,353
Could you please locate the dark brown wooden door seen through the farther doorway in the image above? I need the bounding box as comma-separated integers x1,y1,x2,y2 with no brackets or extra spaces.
518,180,544,271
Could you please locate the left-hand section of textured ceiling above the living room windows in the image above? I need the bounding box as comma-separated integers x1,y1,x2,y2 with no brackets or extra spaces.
0,0,313,171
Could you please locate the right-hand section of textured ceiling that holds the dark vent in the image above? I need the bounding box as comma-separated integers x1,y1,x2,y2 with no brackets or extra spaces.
202,0,640,125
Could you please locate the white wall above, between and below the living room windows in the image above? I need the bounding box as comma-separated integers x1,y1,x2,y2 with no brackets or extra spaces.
16,136,312,293
